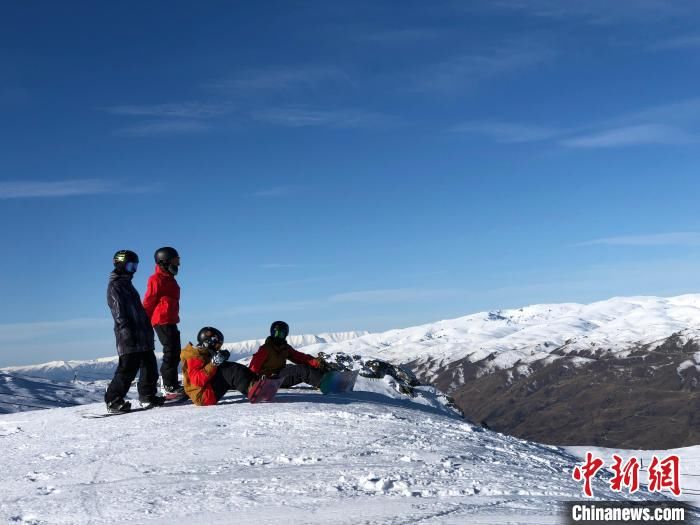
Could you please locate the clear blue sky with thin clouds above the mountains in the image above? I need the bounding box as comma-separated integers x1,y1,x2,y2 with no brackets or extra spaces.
0,0,700,366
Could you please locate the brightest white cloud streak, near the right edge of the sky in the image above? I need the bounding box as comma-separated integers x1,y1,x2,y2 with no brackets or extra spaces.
561,124,698,148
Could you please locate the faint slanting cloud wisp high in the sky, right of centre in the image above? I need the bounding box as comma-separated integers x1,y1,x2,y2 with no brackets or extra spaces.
412,42,556,93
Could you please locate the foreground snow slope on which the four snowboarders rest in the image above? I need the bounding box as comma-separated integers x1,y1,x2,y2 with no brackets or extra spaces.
0,380,688,525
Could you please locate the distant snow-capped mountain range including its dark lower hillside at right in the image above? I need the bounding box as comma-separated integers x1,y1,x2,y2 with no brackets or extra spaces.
0,294,700,448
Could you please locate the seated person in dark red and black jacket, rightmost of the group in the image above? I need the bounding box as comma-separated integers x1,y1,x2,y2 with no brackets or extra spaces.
248,321,324,388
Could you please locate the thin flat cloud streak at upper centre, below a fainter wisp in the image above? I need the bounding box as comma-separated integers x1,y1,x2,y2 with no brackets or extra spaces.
251,107,397,128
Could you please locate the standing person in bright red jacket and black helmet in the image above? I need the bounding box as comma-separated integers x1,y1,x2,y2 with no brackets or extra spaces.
143,246,185,397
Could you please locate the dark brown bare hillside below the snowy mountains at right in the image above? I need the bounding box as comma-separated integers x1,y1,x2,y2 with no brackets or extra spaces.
415,335,700,449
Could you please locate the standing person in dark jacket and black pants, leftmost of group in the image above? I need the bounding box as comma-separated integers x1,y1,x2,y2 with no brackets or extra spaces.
105,250,164,413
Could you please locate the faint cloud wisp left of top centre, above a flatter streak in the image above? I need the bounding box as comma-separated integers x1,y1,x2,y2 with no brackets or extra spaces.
203,65,351,92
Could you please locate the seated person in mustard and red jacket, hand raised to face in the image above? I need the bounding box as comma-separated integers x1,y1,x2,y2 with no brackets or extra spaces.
180,326,257,406
